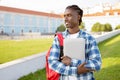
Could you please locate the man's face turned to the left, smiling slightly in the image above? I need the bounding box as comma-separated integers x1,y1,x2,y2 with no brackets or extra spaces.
64,9,80,29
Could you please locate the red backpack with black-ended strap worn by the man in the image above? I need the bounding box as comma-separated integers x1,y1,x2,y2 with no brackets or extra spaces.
46,33,63,80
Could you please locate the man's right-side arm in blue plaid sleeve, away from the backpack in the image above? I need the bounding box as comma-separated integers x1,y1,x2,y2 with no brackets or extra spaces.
85,38,102,70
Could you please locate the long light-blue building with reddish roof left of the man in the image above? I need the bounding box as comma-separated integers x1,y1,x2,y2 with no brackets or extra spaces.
0,6,63,35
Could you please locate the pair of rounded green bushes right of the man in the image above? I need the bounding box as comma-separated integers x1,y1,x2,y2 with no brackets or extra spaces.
91,22,112,32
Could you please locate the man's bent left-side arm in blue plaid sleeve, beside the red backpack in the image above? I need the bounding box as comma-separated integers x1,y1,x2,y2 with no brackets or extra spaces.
48,36,77,75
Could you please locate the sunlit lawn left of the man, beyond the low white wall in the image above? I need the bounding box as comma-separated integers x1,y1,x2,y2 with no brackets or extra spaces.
0,38,53,64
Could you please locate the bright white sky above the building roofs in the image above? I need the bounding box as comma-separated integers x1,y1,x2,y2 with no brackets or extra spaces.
0,0,120,14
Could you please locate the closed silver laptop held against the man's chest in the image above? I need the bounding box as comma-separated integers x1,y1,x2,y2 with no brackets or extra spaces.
63,38,85,60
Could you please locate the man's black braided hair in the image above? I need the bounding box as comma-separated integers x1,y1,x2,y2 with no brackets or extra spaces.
66,5,83,25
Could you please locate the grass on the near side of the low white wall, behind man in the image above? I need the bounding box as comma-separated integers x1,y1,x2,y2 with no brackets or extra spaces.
19,35,120,80
